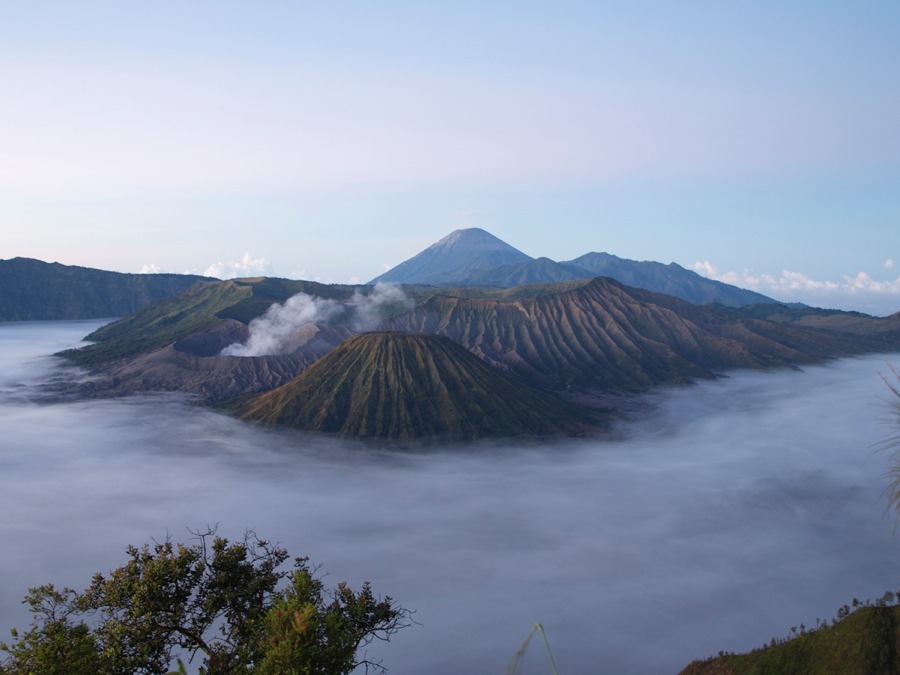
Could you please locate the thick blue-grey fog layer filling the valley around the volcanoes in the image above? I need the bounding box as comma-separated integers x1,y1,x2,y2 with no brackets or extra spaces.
0,322,900,674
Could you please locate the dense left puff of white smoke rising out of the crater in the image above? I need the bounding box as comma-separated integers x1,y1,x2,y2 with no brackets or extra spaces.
222,293,342,356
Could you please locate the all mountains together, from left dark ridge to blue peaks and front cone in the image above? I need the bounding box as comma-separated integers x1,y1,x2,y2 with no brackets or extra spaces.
8,229,900,441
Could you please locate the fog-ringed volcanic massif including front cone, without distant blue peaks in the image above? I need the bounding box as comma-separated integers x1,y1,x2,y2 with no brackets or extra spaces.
60,277,900,440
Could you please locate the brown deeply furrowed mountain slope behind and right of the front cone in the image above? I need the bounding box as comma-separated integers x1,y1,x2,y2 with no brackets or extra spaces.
384,278,854,391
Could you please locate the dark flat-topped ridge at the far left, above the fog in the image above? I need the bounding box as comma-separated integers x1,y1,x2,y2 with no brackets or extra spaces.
0,258,211,321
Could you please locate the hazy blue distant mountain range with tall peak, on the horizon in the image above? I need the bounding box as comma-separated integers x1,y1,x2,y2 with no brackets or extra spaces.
369,228,778,307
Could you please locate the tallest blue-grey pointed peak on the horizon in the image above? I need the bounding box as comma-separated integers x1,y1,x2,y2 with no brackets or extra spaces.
369,227,531,286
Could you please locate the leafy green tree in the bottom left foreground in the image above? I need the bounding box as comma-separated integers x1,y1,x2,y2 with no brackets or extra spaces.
0,530,410,675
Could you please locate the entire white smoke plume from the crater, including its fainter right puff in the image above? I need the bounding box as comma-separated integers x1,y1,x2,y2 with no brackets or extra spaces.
221,283,414,356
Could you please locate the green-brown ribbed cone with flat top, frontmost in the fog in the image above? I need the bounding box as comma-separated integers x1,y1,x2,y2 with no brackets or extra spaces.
237,333,591,441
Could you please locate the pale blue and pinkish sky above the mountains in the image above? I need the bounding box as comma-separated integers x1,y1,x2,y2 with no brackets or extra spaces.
0,0,900,314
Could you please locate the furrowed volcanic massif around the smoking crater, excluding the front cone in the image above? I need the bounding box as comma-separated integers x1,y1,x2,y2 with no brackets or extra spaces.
54,278,900,418
